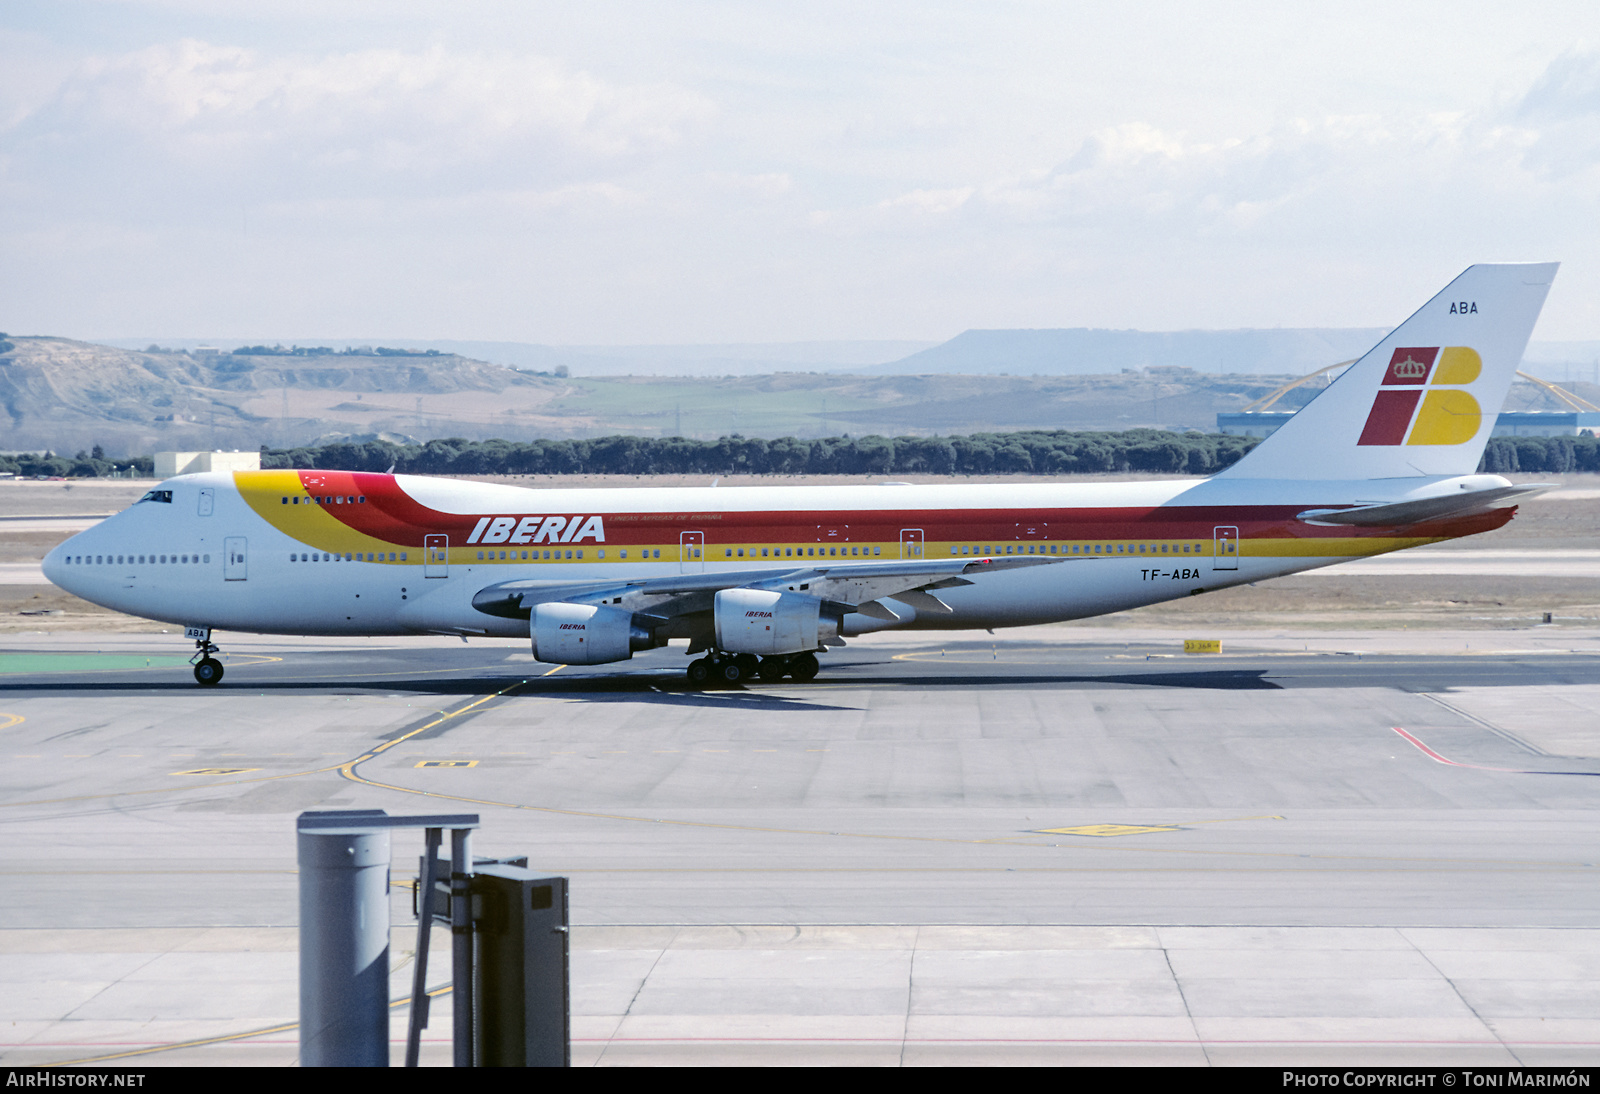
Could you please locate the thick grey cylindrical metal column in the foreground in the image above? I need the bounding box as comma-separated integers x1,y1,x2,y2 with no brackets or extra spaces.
296,811,389,1067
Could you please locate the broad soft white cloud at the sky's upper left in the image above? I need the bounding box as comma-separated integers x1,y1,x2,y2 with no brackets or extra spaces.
0,40,712,187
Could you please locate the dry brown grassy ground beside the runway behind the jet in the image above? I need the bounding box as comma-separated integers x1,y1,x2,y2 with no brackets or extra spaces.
0,475,1600,633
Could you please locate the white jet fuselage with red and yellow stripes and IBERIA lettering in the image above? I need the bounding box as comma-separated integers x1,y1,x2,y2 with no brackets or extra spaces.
45,472,1509,638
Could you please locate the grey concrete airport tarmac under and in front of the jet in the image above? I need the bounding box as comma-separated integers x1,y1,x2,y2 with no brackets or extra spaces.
0,627,1600,1067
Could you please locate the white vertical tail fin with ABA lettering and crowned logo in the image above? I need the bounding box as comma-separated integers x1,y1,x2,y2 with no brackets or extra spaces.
1221,262,1558,478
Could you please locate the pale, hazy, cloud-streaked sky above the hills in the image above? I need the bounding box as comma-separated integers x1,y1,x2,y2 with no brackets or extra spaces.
0,0,1600,344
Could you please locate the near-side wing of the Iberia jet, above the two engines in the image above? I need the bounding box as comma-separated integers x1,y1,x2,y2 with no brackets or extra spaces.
472,555,1072,619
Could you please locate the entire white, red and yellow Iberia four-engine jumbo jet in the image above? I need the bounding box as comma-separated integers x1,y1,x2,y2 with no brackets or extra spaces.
45,264,1555,683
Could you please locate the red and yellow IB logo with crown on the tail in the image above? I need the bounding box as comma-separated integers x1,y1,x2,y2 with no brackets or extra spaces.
1357,345,1483,445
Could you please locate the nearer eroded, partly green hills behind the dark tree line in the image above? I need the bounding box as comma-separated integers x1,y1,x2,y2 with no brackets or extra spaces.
0,331,1600,456
